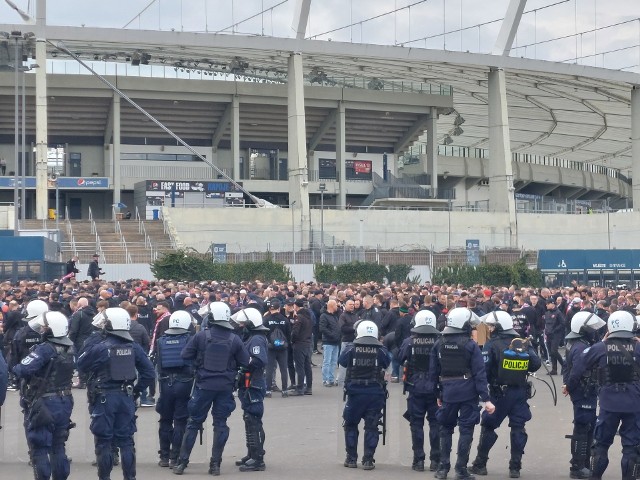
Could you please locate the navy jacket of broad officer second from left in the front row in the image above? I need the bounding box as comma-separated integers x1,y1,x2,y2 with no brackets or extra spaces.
78,332,156,394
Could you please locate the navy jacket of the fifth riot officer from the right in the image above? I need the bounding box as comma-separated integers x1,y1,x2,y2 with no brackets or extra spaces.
398,334,438,394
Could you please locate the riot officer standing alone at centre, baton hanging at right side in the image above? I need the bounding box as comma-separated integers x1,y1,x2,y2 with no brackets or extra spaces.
338,320,390,470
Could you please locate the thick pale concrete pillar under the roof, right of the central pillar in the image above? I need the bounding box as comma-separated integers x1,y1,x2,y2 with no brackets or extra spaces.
489,69,518,248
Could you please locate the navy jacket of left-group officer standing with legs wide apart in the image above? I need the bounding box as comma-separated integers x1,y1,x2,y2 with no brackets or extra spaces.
182,324,249,392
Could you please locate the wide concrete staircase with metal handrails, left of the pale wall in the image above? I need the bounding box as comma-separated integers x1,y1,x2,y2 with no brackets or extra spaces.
20,220,174,264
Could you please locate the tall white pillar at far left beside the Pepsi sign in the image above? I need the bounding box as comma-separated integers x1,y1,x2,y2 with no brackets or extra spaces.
34,36,49,220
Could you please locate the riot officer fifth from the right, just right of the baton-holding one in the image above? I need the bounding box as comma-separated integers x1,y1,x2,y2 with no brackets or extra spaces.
398,310,440,472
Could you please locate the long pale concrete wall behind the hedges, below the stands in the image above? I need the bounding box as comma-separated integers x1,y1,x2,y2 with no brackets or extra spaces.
164,207,640,252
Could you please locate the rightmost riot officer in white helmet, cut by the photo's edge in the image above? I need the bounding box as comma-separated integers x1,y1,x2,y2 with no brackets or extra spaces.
569,310,640,480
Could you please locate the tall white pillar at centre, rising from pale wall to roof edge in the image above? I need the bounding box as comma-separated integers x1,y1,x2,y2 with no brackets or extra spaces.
287,53,310,249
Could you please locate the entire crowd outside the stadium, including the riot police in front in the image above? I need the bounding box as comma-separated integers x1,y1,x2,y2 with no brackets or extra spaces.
0,272,640,479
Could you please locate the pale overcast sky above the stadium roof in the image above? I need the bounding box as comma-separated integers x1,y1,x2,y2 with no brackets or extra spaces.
0,0,640,73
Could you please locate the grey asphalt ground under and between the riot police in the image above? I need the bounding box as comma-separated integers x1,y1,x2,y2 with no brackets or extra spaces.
0,355,621,480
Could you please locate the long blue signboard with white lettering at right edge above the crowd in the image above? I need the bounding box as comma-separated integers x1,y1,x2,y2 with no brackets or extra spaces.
538,250,640,270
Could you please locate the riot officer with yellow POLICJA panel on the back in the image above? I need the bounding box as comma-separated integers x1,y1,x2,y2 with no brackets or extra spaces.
469,310,542,478
